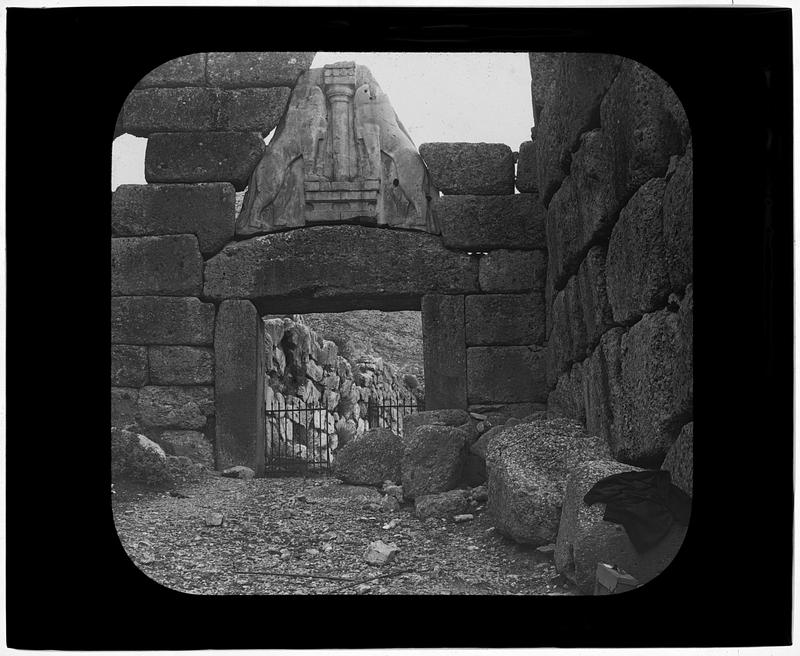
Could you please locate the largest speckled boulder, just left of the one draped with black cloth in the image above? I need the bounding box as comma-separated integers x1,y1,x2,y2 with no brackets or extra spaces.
487,418,609,546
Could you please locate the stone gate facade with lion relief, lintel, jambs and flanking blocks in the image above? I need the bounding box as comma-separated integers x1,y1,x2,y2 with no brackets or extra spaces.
111,52,547,474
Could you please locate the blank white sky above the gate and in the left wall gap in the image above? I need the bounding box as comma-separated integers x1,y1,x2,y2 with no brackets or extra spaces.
111,52,533,189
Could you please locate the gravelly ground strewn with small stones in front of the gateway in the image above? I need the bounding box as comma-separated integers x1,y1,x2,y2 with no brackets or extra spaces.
112,476,576,595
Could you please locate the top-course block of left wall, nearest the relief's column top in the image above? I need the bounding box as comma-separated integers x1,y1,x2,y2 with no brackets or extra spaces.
206,52,316,88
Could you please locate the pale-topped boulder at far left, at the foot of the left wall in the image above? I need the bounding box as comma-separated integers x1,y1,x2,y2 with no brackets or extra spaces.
111,428,172,487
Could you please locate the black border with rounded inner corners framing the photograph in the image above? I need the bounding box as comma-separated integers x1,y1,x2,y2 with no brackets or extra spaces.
5,7,793,650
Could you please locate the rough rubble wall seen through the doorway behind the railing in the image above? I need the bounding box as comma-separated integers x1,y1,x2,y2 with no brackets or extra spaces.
264,315,419,466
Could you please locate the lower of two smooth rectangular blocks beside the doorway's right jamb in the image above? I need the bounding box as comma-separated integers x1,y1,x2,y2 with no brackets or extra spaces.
467,346,547,403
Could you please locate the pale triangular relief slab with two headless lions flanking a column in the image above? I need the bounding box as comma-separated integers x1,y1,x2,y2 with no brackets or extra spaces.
236,62,439,235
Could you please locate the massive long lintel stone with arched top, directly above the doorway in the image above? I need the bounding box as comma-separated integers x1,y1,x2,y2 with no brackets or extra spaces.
205,225,477,300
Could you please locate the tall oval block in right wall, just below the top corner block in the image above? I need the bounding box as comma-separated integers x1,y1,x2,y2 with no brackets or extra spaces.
606,178,670,323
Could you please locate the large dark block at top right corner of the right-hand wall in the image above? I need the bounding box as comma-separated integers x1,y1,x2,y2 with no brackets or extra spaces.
600,59,686,209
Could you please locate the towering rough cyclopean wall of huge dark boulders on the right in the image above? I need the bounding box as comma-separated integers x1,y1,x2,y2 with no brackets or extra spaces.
518,53,693,467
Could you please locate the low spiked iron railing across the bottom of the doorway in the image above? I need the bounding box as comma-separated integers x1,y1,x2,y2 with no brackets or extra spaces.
264,399,423,476
